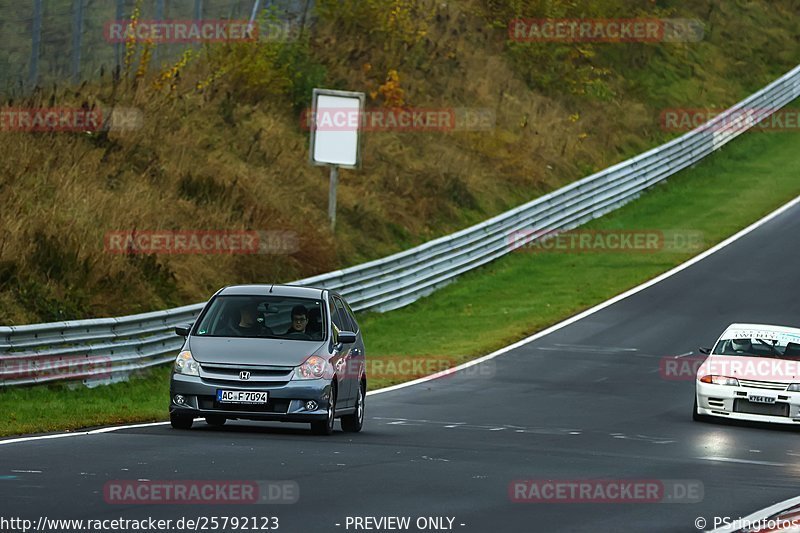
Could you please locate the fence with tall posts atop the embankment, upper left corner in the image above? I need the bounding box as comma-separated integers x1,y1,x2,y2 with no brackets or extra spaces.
0,0,313,95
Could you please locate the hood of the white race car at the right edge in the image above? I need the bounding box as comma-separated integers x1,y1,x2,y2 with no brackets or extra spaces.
697,355,800,382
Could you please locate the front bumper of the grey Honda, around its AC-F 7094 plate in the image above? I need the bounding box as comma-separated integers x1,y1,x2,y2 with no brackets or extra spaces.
169,374,331,422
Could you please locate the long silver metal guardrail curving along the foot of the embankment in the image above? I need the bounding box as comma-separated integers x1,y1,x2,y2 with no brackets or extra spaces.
0,66,800,386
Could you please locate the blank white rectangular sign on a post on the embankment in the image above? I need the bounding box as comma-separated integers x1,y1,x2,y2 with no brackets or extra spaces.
309,89,365,231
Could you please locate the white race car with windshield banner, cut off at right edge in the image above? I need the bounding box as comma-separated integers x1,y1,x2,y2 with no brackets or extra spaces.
692,324,800,424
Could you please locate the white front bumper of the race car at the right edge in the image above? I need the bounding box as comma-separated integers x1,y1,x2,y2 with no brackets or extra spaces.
695,381,800,424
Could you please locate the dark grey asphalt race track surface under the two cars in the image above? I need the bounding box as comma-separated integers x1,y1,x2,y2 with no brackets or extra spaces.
0,201,800,533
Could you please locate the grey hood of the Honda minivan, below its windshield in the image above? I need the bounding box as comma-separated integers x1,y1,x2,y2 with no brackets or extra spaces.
188,336,325,366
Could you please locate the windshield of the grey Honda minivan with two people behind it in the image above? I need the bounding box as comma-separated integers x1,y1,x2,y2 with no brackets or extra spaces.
193,296,325,341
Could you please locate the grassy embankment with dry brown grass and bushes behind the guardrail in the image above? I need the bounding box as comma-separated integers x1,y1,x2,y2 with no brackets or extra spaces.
0,0,800,324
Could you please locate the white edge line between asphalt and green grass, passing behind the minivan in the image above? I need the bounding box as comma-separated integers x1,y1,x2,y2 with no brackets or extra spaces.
0,196,800,446
